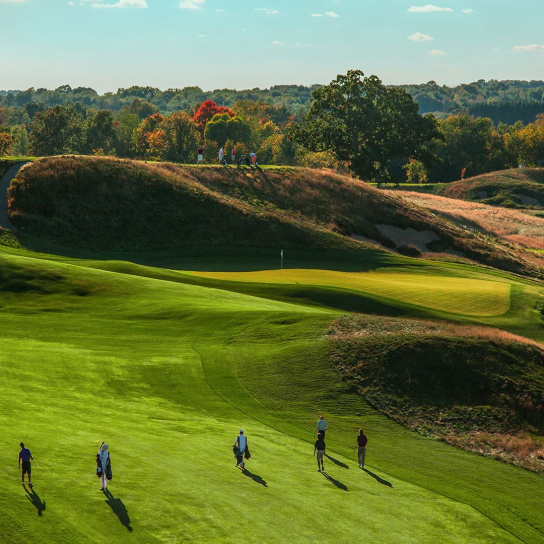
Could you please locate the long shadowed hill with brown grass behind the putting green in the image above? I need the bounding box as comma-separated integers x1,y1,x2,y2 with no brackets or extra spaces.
8,156,542,277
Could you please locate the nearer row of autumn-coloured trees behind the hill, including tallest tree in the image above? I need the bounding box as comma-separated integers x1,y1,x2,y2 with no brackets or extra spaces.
0,70,544,182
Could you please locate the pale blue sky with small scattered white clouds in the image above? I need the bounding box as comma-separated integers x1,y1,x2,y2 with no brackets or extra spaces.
0,0,544,93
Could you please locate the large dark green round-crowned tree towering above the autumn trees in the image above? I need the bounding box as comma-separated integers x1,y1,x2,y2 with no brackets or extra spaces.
294,70,438,179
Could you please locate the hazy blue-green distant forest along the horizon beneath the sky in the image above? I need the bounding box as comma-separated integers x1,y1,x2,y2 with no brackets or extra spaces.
0,80,544,125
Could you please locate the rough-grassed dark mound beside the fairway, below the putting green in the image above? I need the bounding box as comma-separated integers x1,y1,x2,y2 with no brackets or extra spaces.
328,316,544,474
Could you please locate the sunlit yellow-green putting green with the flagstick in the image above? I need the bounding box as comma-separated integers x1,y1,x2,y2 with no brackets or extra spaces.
193,269,510,317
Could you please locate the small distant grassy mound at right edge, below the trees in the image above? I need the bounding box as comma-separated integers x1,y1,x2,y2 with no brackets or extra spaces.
437,168,544,209
